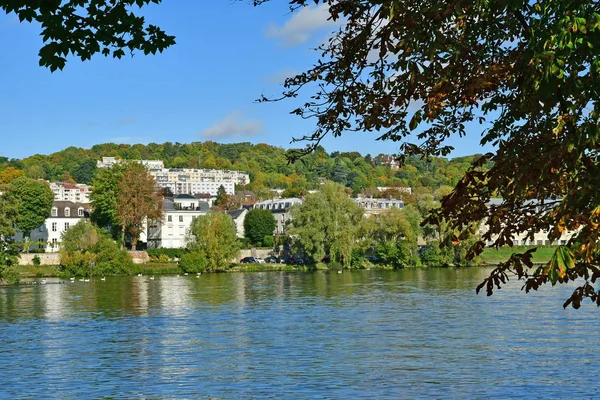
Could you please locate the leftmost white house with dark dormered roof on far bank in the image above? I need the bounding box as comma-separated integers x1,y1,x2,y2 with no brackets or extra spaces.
14,201,90,253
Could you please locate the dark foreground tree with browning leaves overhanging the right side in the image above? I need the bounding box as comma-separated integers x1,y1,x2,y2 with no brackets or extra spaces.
262,0,600,308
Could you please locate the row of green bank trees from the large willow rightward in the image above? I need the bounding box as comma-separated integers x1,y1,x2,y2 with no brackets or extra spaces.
288,182,478,267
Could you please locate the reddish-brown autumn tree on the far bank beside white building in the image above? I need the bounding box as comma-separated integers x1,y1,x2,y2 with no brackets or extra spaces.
116,163,163,250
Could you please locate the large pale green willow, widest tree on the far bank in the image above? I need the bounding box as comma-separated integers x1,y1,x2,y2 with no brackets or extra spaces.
288,182,363,266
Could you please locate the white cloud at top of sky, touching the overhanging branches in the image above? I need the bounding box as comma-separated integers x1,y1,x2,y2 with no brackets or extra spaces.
267,3,340,46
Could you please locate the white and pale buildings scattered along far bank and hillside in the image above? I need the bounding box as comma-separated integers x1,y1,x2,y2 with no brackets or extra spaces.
15,157,573,252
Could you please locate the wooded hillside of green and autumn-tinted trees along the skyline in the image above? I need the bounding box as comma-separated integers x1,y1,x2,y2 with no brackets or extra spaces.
0,142,482,197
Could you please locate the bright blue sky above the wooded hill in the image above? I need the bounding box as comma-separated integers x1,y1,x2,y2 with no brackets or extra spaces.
0,0,492,158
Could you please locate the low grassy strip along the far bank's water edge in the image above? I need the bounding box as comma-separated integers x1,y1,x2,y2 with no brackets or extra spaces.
5,246,555,279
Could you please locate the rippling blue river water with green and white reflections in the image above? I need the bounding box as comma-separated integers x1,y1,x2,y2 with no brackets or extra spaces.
0,268,600,399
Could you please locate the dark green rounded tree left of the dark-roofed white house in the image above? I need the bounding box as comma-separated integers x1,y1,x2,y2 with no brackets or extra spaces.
9,177,54,248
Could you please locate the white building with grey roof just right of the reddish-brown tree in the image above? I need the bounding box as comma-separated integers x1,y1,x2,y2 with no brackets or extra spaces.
146,194,210,249
